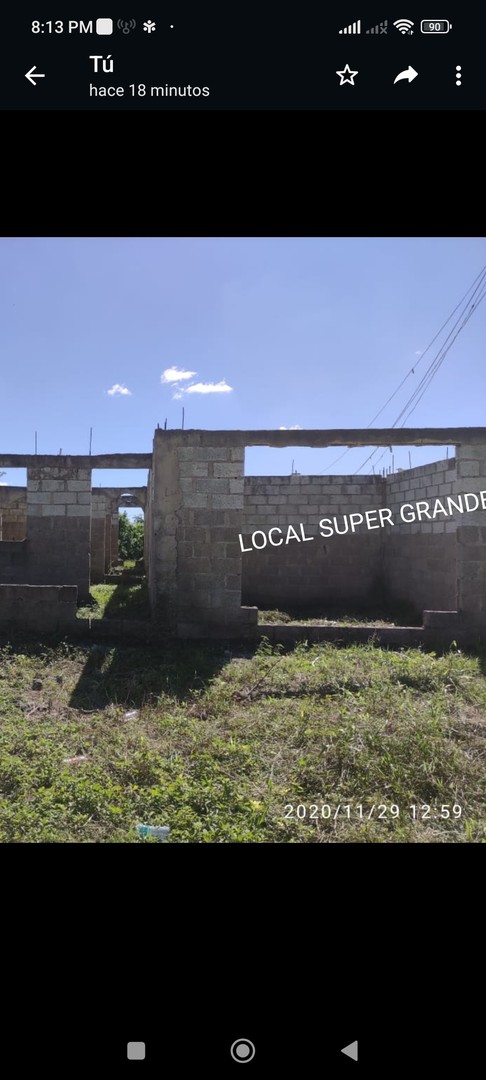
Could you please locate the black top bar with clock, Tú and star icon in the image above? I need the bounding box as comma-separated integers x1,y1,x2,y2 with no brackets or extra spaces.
0,9,486,111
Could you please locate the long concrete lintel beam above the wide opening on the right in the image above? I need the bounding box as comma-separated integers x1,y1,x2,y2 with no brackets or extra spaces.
153,428,486,449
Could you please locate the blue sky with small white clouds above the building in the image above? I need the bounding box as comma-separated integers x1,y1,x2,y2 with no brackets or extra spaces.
0,237,486,514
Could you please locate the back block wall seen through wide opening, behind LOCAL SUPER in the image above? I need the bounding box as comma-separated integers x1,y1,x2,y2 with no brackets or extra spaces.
242,475,386,612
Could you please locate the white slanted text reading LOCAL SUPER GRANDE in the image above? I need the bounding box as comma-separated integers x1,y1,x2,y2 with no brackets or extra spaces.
239,490,486,552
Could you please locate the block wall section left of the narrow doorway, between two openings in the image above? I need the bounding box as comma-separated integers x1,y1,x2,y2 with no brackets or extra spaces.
27,464,92,602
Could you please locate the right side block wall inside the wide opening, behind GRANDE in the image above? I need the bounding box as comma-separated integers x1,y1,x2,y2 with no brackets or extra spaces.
383,458,460,616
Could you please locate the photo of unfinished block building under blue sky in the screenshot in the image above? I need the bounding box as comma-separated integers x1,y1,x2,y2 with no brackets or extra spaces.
0,235,486,842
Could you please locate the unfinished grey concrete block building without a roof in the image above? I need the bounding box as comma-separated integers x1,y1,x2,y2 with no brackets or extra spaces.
0,428,486,638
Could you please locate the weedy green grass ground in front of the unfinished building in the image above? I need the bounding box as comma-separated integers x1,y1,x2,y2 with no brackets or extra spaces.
0,630,486,843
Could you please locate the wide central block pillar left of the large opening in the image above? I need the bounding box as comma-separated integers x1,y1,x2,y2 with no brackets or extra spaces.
150,430,257,637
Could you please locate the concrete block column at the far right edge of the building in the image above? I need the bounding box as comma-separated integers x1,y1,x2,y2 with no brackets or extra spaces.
457,444,486,627
